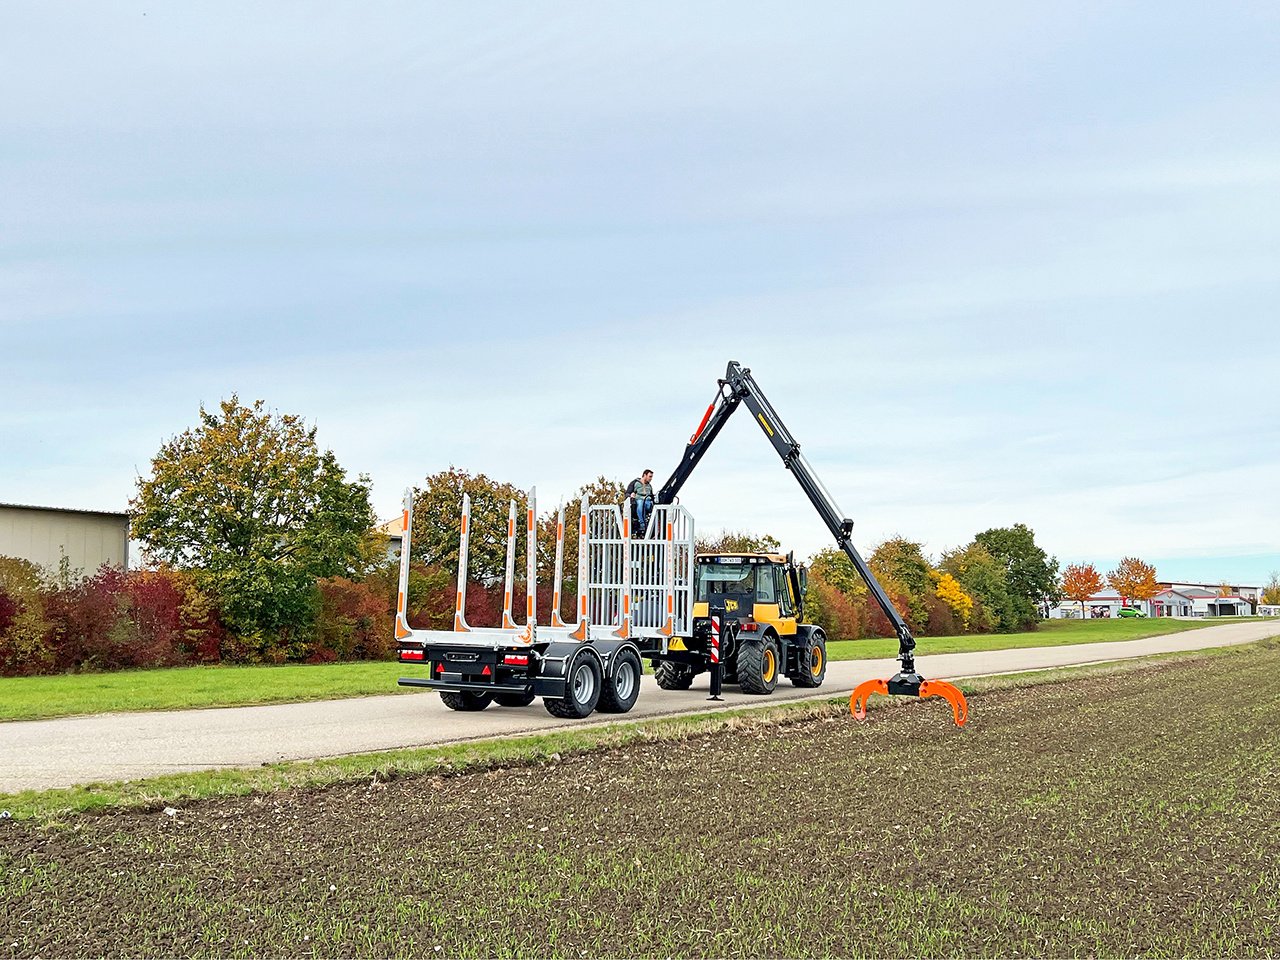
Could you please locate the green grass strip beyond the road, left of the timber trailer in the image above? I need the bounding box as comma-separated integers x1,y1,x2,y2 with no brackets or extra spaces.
0,662,415,721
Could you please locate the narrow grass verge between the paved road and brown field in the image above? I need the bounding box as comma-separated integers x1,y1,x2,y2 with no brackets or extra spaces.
0,640,1259,826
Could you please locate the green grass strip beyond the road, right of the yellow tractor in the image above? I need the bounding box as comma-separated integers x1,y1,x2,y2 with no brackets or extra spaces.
827,617,1264,660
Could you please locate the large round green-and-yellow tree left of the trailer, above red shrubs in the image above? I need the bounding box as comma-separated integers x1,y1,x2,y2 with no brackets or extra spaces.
129,396,375,650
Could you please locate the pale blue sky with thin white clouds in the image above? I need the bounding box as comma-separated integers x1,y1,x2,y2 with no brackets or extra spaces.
0,0,1280,584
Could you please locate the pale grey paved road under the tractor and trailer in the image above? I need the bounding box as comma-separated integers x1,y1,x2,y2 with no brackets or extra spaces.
0,622,1280,794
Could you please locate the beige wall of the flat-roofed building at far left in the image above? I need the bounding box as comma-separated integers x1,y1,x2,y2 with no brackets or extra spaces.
0,504,129,573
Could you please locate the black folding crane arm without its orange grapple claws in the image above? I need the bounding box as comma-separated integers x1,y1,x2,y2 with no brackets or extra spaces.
658,360,920,686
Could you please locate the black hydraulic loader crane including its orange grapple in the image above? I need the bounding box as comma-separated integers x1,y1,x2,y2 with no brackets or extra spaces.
657,360,969,726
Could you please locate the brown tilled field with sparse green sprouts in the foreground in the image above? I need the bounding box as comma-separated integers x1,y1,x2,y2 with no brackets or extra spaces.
0,644,1280,957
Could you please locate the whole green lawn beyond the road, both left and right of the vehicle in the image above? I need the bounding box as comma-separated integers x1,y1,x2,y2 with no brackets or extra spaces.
0,617,1259,721
